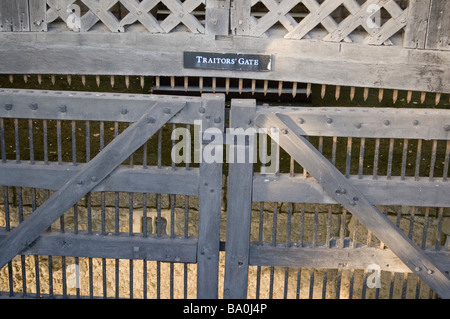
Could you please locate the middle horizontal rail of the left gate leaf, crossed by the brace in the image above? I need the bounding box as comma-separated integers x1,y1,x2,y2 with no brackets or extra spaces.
0,162,199,196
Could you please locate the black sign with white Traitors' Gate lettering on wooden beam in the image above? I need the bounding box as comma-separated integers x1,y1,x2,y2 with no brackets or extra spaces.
184,52,272,72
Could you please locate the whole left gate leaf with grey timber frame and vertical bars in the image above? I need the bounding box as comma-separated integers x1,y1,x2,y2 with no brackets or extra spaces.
0,89,225,298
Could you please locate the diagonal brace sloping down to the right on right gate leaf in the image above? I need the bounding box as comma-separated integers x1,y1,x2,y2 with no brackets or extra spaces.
255,113,450,298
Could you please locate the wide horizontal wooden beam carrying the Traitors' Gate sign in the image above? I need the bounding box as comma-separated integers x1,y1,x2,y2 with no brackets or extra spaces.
0,31,450,93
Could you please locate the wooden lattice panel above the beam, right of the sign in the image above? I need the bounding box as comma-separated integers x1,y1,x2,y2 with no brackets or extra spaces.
246,0,408,45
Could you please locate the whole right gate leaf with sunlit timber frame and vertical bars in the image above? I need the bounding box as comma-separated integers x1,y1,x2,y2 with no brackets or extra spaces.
224,100,450,298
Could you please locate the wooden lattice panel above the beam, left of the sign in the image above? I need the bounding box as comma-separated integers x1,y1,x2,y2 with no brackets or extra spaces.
47,0,205,33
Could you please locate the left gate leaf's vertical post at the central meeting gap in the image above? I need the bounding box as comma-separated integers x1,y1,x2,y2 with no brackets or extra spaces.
197,94,225,299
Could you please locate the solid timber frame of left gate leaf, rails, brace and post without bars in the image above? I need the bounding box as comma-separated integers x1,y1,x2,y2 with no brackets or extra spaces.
0,89,225,299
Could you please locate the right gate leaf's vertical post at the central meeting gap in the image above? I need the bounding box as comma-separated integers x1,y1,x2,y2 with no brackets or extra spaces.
223,100,256,299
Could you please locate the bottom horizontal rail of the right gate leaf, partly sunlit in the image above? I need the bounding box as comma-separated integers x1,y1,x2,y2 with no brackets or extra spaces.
250,243,450,273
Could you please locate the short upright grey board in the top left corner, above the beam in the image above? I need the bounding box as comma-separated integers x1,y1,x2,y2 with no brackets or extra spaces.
0,0,30,32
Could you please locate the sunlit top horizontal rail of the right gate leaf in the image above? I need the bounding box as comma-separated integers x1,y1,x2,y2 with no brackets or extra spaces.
258,107,450,140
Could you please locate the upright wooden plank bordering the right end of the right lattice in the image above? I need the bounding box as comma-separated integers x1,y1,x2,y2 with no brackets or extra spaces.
403,0,431,49
